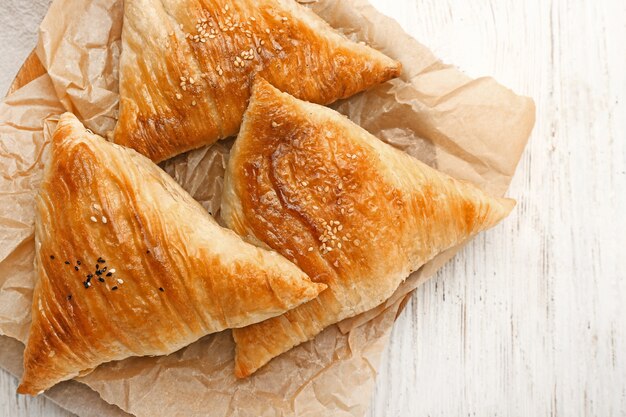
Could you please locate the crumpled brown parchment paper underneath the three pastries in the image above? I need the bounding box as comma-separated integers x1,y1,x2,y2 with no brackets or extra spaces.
0,0,534,416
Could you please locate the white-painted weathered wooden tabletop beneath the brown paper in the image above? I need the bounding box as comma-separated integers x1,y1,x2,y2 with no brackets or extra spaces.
0,0,626,417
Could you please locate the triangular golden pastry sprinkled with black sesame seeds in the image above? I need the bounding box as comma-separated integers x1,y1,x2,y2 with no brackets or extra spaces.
18,114,325,394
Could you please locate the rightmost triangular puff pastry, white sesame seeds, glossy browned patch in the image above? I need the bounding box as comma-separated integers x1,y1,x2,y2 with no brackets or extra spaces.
222,80,515,377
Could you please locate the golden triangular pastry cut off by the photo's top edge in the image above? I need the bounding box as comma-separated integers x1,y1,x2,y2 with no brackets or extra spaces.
115,0,401,162
